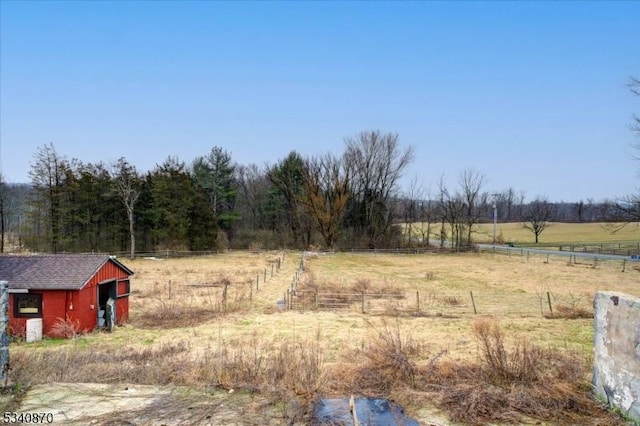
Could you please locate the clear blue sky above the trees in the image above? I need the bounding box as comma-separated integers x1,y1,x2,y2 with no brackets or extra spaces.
0,1,640,201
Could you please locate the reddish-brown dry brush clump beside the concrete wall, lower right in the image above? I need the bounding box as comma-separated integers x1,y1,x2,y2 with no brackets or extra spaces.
425,318,623,425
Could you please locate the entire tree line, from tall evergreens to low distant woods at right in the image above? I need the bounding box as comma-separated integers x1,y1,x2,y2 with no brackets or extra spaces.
0,127,636,257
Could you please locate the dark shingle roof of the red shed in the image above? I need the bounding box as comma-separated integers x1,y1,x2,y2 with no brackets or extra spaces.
0,254,133,290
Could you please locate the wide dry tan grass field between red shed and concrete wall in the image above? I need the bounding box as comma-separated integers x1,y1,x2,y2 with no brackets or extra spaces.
11,252,640,425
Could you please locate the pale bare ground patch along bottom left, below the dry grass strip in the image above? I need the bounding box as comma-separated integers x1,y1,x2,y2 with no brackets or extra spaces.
17,383,302,426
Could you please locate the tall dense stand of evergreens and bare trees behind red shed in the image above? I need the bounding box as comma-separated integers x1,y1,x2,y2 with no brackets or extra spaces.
0,131,413,256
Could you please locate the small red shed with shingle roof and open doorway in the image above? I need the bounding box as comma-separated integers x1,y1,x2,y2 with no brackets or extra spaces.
0,254,133,336
